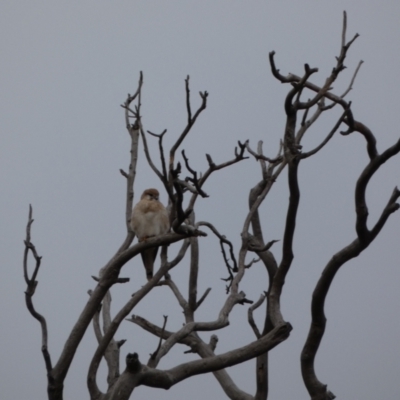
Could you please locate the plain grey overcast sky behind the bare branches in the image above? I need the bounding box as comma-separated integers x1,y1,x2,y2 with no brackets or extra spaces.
0,0,400,400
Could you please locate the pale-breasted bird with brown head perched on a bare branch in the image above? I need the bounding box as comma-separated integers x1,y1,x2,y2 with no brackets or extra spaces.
130,189,170,280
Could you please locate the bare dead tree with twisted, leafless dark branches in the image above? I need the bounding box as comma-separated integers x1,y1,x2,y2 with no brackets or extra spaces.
23,13,400,400
